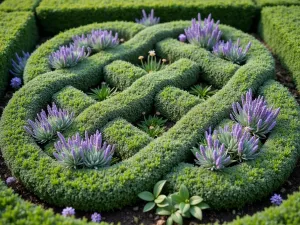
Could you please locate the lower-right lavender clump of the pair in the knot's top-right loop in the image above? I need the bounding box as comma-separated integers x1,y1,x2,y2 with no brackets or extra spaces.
213,39,251,64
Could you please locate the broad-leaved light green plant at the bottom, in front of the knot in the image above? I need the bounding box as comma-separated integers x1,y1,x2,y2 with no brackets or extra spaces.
138,180,209,225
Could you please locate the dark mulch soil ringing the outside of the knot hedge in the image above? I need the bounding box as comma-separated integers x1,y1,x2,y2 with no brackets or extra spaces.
0,35,300,225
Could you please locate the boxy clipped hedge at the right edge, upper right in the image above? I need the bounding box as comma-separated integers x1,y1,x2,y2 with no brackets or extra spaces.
259,6,300,90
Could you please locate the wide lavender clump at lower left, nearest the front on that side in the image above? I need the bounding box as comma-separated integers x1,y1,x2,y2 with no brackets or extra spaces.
54,130,115,169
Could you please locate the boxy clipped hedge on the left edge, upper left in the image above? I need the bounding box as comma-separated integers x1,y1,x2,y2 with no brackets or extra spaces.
0,11,38,97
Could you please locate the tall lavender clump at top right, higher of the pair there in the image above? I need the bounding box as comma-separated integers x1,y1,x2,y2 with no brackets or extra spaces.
184,13,222,50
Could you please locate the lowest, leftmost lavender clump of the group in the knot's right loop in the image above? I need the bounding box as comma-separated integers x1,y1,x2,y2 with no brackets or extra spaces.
195,134,232,170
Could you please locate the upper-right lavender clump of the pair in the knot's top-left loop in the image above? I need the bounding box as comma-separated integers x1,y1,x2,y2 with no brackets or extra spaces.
73,30,119,52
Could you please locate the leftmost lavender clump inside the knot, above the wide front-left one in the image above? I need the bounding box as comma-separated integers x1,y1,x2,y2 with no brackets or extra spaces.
24,103,74,143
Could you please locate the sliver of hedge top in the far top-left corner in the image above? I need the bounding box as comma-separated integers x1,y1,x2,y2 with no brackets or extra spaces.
0,0,41,12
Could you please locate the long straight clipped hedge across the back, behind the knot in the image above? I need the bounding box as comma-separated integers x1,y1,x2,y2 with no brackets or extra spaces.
37,0,258,33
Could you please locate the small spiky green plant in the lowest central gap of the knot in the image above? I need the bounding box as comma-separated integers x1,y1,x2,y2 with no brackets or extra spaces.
138,115,167,138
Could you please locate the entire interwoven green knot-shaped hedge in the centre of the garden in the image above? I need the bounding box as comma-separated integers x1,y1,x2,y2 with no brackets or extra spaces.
0,22,299,219
